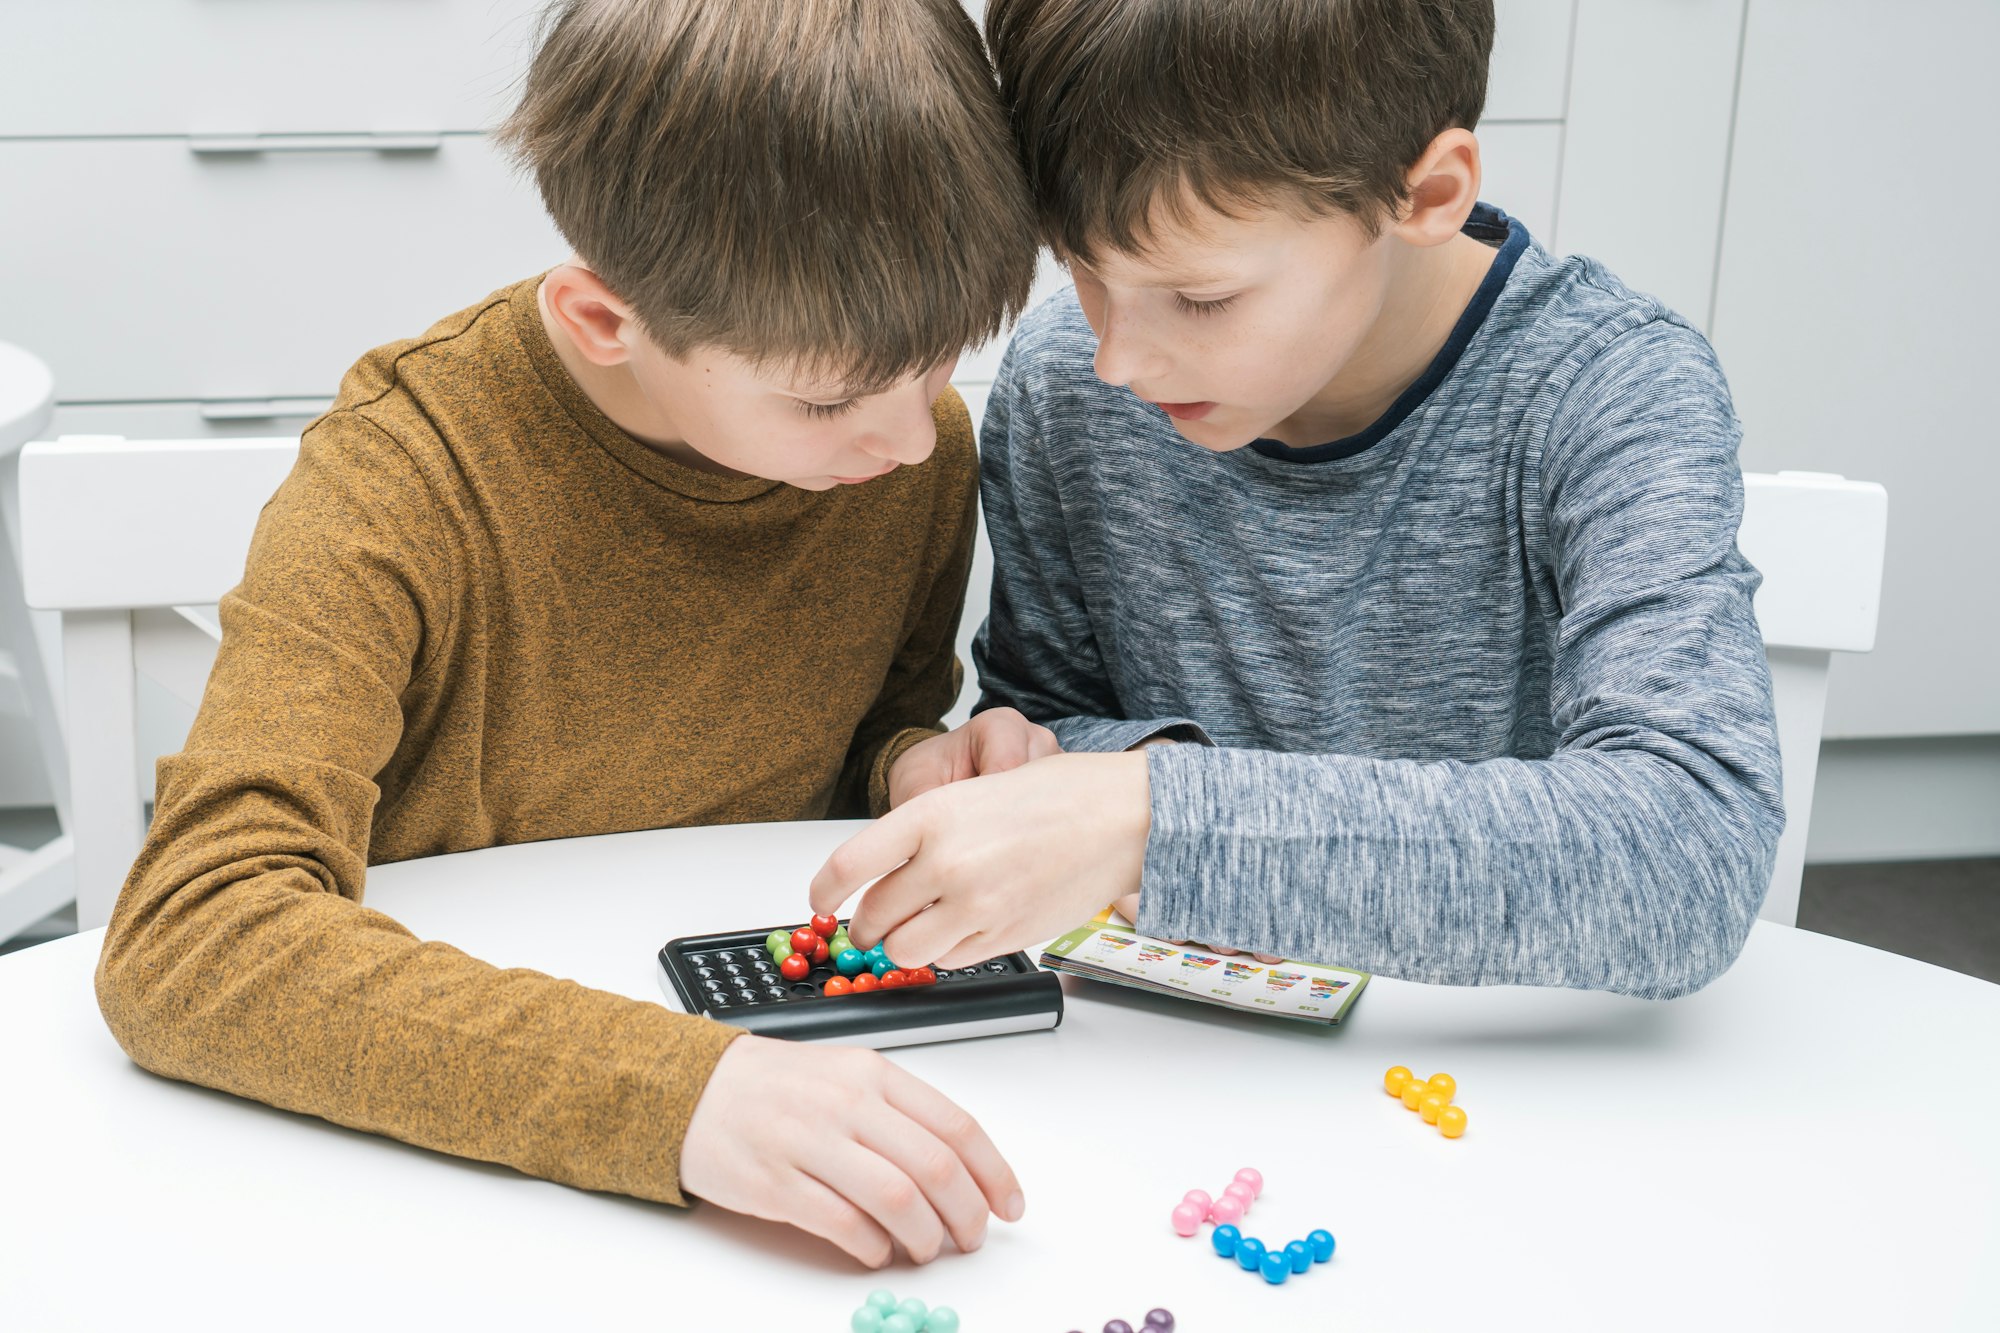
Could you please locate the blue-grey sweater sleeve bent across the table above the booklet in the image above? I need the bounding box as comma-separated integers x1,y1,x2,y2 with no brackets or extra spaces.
1138,320,1784,999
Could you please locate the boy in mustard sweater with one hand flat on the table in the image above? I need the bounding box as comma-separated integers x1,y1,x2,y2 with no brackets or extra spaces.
98,0,1054,1265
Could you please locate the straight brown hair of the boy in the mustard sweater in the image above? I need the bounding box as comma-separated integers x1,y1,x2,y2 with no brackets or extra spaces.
498,0,1036,392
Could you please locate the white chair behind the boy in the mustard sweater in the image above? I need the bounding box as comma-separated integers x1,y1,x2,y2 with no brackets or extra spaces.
20,436,298,931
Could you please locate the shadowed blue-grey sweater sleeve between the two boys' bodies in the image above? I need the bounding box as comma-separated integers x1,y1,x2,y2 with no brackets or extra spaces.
972,340,1208,753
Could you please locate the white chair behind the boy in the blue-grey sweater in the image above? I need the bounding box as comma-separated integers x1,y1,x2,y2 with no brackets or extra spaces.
1736,472,1888,925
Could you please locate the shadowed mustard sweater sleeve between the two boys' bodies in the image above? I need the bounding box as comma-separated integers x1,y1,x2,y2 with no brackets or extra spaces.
832,388,980,819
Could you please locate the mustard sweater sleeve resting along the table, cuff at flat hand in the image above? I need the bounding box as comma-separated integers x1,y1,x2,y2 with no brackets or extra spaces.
96,412,740,1203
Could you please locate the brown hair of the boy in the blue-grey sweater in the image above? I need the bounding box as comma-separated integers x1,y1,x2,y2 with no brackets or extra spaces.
986,0,1494,260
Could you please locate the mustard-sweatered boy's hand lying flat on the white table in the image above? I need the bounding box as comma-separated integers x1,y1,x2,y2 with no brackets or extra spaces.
680,1037,1024,1269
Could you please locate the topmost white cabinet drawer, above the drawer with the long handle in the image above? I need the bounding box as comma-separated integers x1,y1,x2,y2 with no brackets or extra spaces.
0,0,540,136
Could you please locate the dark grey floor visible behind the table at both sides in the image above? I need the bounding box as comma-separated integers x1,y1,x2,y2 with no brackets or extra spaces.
0,811,2000,983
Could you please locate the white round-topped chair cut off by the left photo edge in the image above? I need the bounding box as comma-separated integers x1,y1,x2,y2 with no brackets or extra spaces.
0,342,76,941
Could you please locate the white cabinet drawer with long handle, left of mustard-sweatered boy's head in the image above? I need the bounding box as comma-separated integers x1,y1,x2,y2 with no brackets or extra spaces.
0,134,568,402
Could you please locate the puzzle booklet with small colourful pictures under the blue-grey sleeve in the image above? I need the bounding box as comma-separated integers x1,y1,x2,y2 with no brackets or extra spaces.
1042,907,1368,1027
